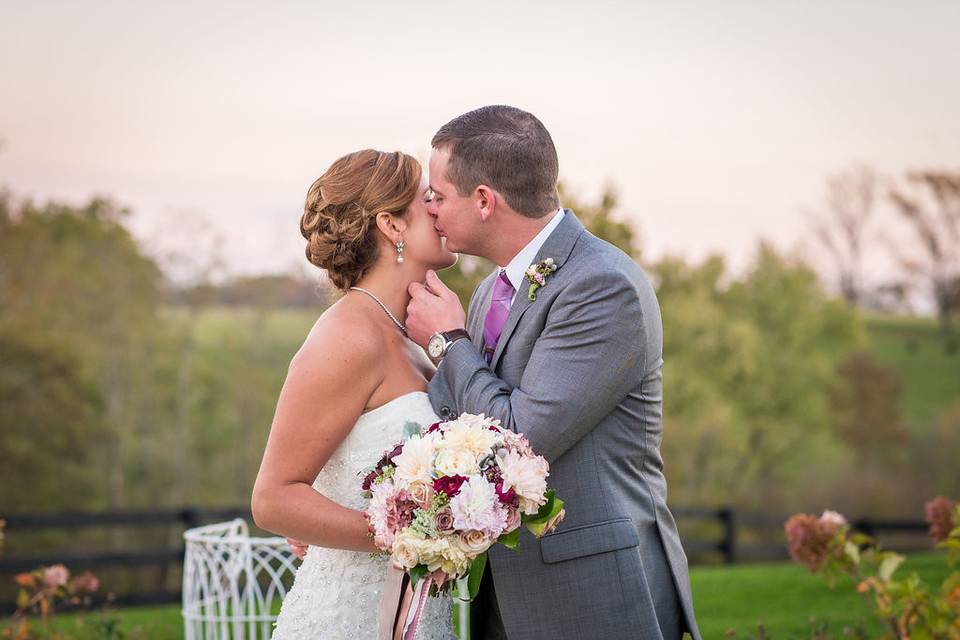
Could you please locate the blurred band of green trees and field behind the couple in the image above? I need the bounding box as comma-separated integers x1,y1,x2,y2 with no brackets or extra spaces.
0,173,960,516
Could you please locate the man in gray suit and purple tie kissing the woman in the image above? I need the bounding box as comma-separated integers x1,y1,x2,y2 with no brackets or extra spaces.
407,106,700,640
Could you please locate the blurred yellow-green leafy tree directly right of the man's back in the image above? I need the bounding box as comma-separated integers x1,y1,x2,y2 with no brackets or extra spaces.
650,244,862,506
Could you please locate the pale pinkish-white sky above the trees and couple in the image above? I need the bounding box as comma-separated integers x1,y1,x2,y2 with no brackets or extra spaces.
0,0,960,282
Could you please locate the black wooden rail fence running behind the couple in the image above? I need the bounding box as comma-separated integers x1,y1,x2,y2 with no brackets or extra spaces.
0,507,930,612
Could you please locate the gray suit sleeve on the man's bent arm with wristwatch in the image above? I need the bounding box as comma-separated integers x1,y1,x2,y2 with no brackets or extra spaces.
440,271,646,462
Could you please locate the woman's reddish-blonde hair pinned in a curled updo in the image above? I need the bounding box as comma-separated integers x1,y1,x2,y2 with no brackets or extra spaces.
300,149,422,290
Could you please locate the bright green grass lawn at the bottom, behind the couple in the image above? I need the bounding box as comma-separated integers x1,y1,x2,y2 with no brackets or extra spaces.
48,552,947,640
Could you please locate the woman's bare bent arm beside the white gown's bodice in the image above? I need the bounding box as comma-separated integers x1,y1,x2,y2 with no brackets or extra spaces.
251,323,383,551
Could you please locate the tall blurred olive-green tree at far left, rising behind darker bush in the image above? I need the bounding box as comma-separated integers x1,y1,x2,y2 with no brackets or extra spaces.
0,194,163,506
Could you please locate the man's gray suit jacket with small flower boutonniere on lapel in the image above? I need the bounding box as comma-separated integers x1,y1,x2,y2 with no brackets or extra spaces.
429,209,700,640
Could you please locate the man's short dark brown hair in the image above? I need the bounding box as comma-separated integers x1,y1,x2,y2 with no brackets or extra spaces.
431,105,560,218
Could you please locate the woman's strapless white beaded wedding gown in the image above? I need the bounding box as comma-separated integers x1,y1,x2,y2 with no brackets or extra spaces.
273,391,454,640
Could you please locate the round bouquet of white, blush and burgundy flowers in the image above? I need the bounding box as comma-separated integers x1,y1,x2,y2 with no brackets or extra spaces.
363,413,564,598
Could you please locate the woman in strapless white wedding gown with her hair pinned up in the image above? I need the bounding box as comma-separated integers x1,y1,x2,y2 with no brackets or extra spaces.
251,149,457,640
